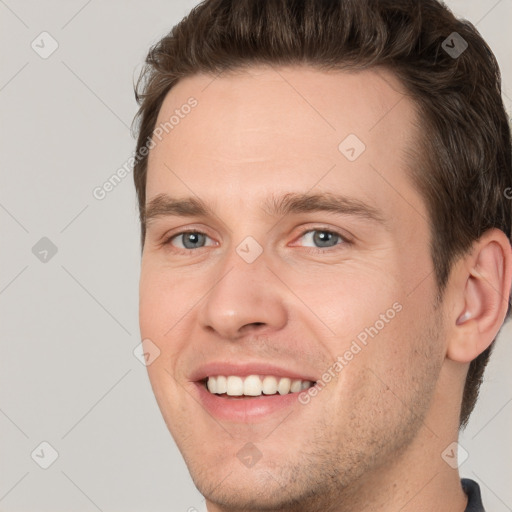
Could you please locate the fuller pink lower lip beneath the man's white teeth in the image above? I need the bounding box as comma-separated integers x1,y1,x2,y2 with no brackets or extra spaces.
195,382,300,423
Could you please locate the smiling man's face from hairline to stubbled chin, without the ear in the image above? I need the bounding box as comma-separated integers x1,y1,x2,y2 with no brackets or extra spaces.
140,67,444,510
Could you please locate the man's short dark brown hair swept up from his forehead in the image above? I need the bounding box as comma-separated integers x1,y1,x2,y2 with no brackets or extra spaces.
134,0,512,427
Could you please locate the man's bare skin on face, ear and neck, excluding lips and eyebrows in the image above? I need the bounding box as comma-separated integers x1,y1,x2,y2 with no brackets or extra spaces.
140,66,511,512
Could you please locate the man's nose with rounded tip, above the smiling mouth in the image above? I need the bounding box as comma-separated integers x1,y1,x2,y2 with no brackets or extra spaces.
198,251,287,340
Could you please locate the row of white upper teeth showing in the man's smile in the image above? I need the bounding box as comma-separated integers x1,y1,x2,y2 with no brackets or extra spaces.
207,375,313,396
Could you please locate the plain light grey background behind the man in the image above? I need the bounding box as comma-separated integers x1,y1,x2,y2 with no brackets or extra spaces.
0,0,512,512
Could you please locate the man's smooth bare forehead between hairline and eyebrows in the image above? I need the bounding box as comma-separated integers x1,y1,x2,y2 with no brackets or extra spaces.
146,66,423,222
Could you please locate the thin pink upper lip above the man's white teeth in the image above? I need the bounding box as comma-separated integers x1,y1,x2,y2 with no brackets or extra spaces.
190,361,317,382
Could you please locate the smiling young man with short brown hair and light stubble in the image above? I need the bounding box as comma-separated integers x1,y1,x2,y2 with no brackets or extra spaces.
134,0,512,512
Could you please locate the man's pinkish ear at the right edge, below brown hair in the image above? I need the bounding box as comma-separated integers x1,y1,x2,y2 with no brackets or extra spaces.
446,229,512,363
